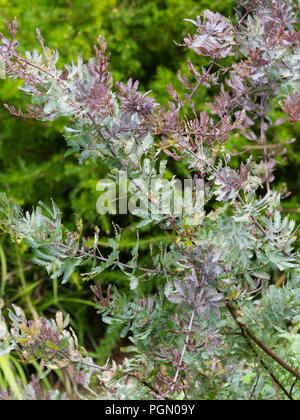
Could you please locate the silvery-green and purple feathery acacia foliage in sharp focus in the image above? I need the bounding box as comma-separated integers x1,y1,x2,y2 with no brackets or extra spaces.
0,0,300,400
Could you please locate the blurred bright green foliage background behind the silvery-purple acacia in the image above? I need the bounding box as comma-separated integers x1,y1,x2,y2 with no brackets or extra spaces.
0,0,300,394
